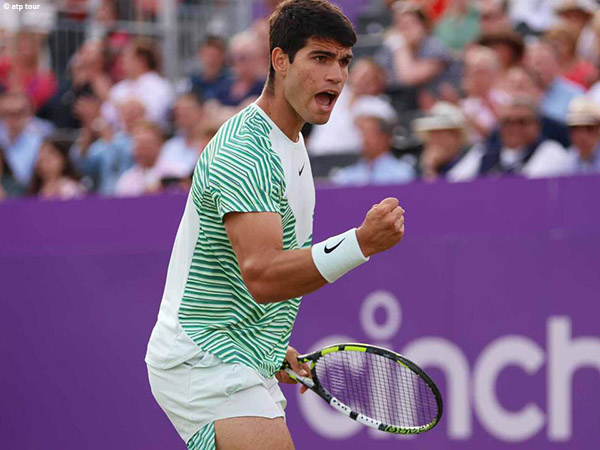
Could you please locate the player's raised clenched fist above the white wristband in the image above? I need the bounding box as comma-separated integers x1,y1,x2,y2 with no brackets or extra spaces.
356,197,404,257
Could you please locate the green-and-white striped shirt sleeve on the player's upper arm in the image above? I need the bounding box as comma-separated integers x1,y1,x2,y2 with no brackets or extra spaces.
210,145,285,218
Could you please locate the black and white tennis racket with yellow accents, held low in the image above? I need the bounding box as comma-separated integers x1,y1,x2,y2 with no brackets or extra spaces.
282,344,443,434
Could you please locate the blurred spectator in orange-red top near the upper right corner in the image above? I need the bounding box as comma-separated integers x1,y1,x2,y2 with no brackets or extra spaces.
544,22,598,89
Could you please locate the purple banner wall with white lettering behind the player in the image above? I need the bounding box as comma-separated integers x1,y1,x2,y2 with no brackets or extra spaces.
0,177,600,450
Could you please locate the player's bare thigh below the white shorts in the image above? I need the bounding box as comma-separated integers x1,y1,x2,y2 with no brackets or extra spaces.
215,417,294,450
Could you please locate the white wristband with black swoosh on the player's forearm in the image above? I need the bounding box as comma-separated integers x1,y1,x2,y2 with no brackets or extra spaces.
311,228,369,283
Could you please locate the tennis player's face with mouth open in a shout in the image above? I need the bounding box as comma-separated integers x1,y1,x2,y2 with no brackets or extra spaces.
283,38,352,125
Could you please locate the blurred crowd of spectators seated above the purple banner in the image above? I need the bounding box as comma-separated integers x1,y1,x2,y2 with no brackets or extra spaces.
0,0,600,199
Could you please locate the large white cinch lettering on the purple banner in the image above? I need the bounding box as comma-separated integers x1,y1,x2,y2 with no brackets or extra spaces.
298,291,600,442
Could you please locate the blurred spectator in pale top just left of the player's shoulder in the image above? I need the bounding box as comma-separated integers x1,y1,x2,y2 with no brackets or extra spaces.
159,94,206,174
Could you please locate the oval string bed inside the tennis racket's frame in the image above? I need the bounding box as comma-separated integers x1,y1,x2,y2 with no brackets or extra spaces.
316,351,438,428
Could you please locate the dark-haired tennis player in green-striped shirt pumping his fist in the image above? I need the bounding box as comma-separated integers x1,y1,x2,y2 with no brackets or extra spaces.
146,0,404,450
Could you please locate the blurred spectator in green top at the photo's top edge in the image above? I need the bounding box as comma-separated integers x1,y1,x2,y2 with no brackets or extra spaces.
434,0,480,52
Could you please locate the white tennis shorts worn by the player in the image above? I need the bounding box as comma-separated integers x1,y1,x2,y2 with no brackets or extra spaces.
147,352,287,443
